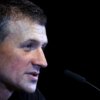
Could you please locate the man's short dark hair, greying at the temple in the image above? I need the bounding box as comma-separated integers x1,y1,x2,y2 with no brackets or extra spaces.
0,0,47,42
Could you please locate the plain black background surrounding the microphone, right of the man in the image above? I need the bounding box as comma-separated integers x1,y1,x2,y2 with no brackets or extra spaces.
31,0,100,100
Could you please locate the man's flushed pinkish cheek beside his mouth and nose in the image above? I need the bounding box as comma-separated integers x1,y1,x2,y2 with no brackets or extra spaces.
0,52,30,79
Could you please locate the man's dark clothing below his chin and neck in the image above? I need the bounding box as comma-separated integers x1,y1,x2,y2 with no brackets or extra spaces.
8,89,45,100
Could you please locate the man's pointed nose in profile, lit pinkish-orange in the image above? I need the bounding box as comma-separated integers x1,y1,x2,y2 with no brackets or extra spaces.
32,48,48,68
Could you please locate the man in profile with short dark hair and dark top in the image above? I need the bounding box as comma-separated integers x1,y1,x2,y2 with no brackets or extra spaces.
0,0,48,100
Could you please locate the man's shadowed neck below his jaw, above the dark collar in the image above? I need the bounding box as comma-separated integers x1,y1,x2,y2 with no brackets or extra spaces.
0,83,12,100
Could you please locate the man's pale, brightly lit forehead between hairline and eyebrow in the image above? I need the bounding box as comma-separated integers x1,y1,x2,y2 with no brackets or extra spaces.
7,20,48,43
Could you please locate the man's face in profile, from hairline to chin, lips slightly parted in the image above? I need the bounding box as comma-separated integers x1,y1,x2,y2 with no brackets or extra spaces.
0,20,47,92
